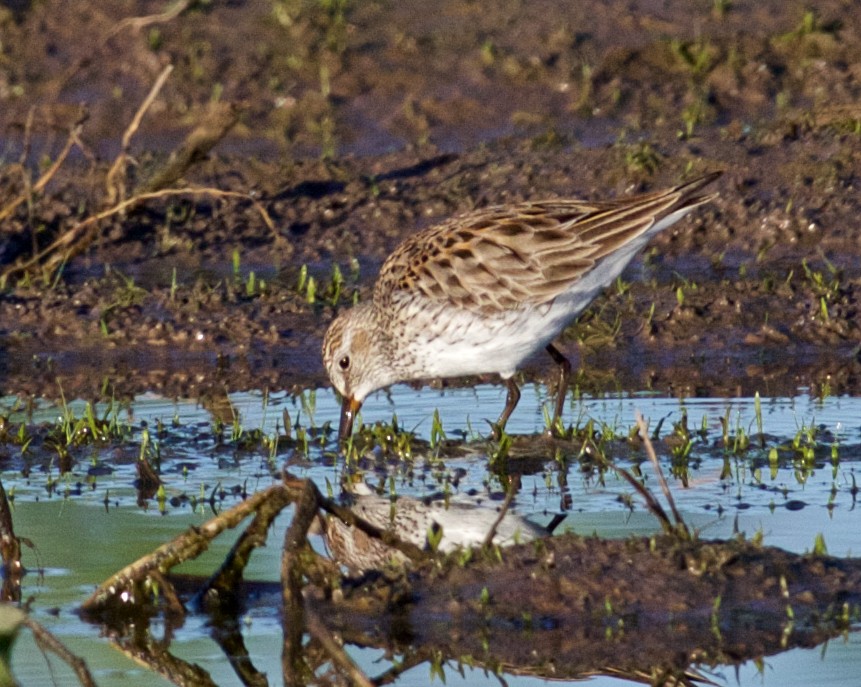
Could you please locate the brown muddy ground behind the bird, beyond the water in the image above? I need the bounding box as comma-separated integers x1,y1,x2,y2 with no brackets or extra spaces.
0,0,861,398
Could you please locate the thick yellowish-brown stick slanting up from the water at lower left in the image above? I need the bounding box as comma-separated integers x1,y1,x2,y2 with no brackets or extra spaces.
81,484,284,612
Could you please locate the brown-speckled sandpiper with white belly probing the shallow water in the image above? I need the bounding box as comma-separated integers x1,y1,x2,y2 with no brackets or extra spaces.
323,172,721,439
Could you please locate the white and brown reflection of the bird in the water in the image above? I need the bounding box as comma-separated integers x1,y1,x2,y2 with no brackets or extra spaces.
323,483,550,574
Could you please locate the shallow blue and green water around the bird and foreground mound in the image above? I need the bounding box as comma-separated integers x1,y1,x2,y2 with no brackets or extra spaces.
2,385,861,686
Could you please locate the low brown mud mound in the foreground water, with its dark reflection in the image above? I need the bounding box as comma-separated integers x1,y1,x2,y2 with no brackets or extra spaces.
312,534,861,684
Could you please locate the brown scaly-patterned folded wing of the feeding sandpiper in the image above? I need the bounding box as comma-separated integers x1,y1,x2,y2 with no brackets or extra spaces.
374,175,717,312
